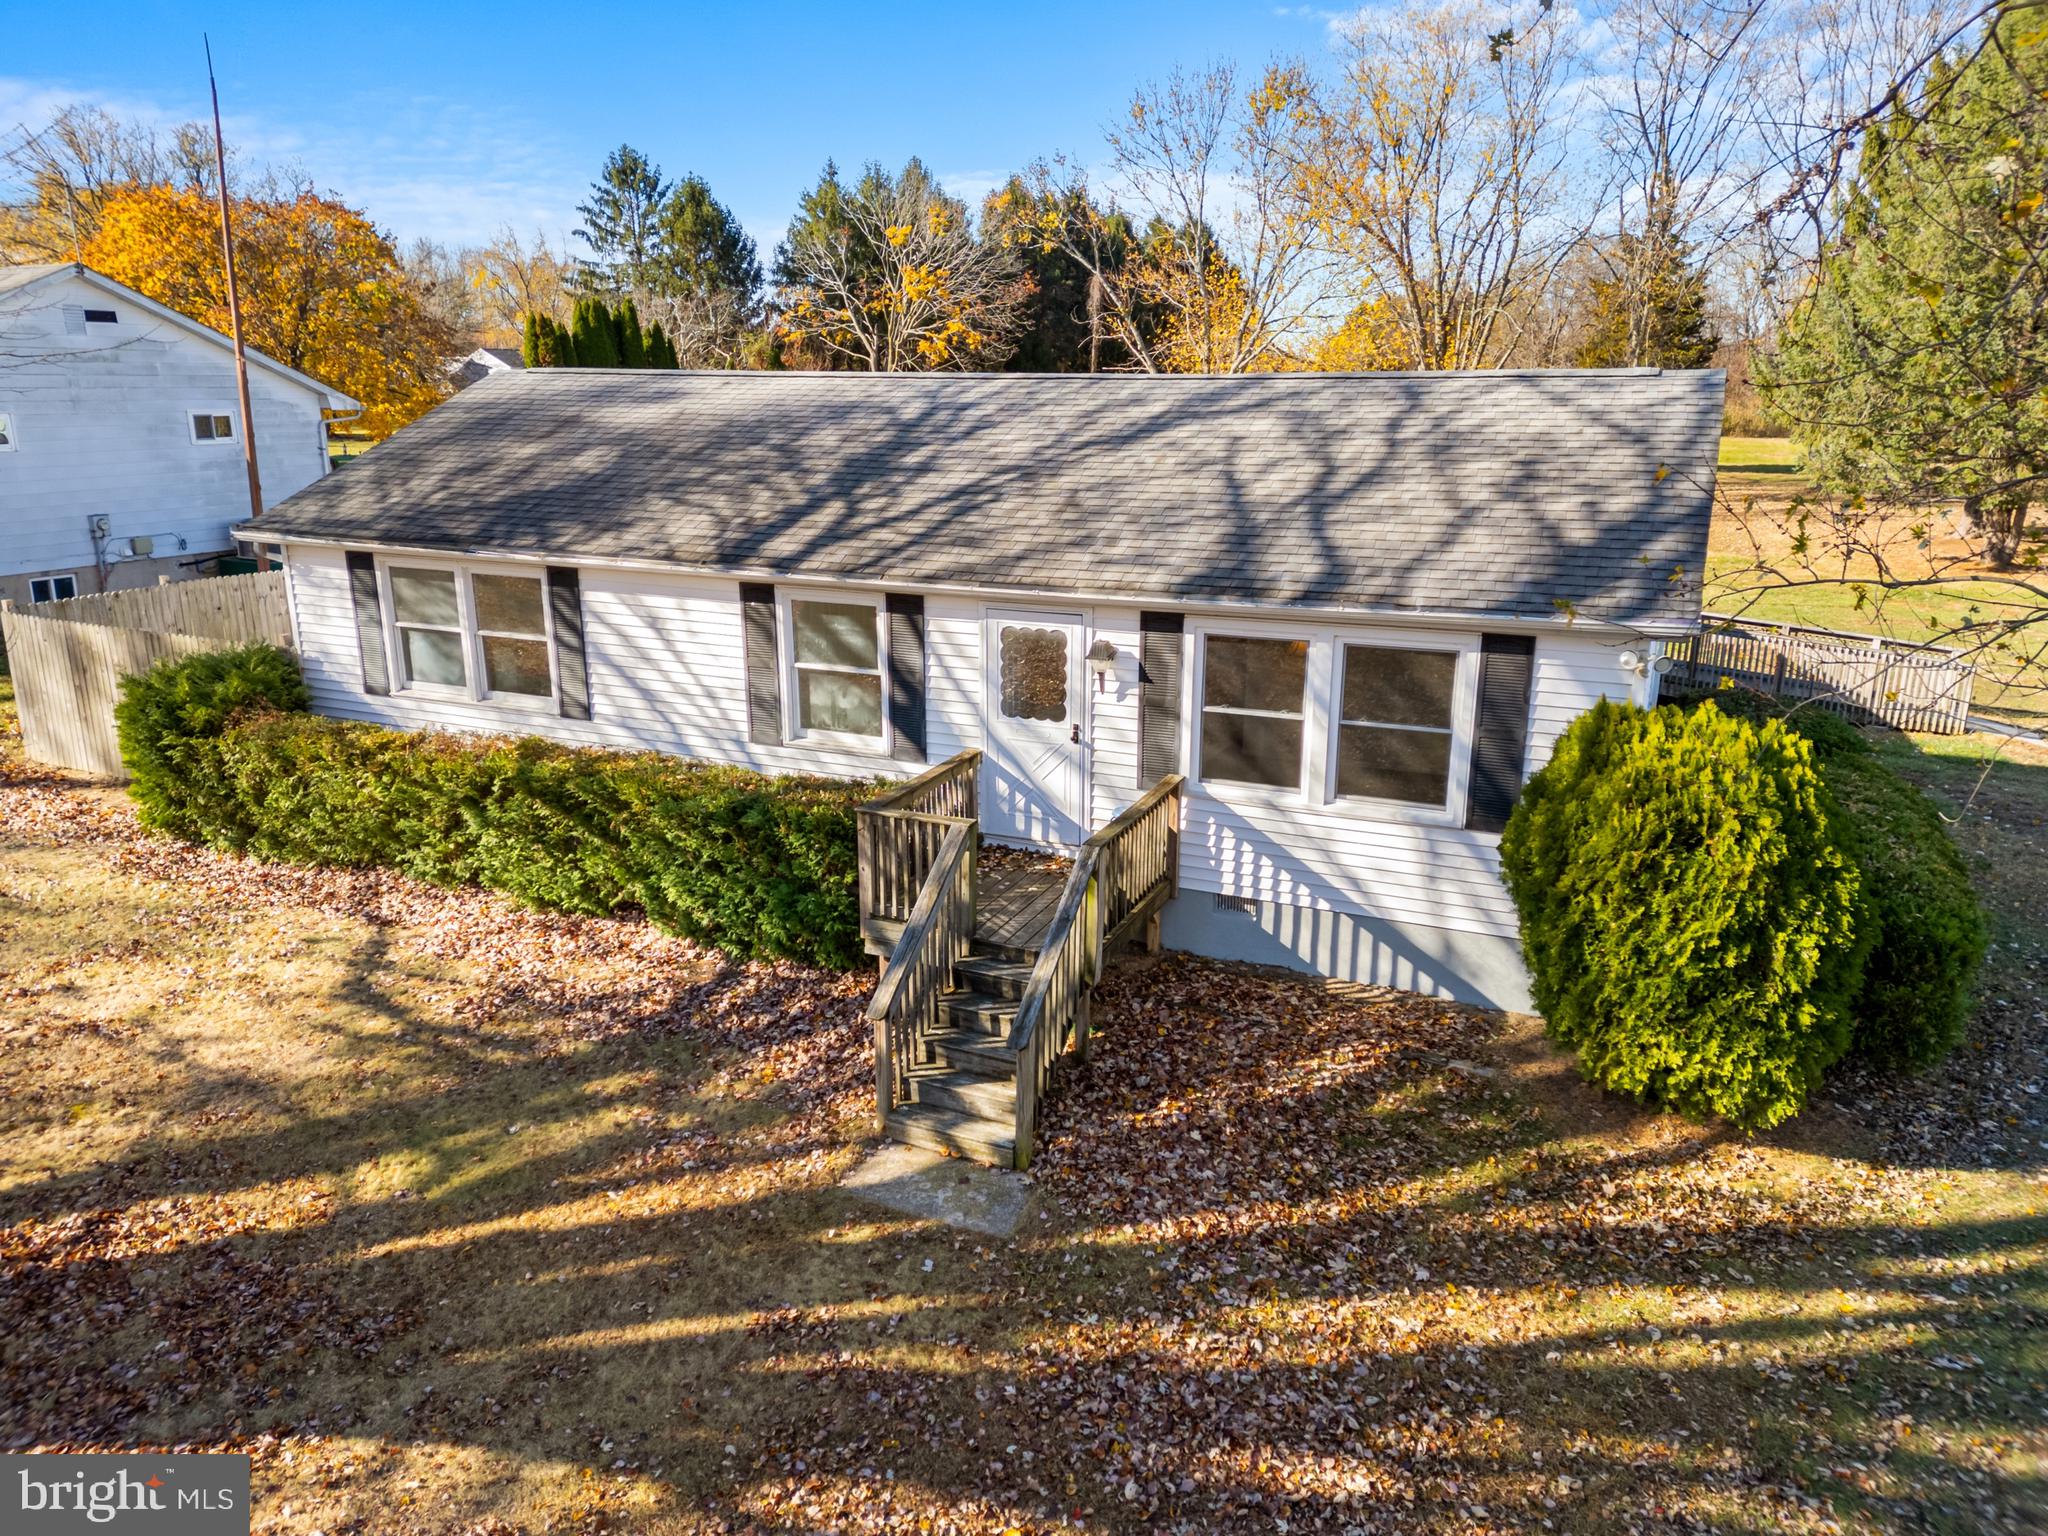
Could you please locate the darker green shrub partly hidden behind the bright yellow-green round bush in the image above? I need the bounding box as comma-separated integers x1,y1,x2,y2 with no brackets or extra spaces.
1679,690,1989,1069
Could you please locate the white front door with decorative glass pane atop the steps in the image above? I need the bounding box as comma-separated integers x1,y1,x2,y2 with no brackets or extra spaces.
981,608,1087,848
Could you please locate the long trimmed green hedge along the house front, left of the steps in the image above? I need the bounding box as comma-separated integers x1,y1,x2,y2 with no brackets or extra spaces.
117,647,874,967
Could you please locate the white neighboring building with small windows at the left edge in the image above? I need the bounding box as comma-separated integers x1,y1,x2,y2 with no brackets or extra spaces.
0,262,358,602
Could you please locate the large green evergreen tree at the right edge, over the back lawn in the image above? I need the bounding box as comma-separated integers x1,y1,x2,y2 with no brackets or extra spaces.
1759,10,2048,569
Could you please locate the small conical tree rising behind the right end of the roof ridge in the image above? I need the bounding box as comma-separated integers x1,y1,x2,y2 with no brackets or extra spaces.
1573,197,1720,369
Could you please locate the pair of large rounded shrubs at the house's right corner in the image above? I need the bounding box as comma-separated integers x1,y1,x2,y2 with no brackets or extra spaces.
1501,700,1985,1128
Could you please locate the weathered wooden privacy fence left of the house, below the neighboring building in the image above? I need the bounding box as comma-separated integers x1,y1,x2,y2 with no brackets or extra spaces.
0,571,291,778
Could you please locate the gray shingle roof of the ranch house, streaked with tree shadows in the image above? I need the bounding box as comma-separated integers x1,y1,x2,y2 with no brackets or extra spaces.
262,369,1722,625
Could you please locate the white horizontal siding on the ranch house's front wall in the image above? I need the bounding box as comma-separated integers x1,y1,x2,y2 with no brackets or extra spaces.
287,545,1642,938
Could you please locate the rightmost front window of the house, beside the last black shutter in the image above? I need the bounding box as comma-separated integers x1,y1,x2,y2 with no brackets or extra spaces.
1337,645,1458,805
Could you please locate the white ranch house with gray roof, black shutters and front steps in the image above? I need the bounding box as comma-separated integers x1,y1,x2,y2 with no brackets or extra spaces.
244,369,1722,1157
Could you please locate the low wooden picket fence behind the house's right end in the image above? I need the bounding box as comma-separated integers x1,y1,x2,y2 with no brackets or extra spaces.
1669,614,1976,735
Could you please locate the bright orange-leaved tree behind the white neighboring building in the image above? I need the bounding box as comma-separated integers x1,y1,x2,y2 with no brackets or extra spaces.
82,186,455,438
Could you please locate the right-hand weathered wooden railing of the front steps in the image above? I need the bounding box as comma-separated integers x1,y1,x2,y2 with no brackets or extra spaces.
1010,774,1186,1169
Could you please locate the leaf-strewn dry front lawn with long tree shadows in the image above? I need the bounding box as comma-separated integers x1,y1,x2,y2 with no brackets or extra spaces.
0,688,2048,1536
